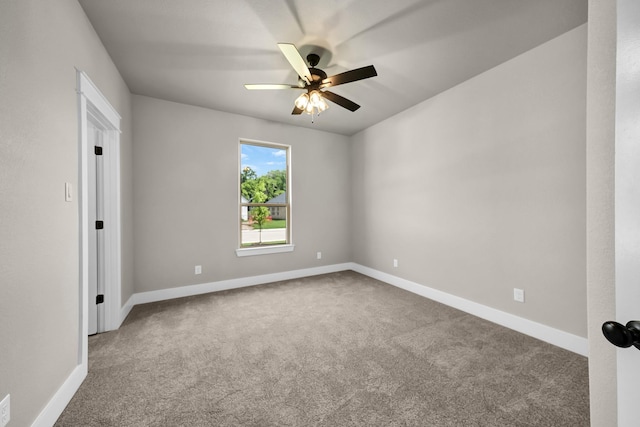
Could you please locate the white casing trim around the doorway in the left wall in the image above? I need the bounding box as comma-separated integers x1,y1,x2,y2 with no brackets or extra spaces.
76,70,122,367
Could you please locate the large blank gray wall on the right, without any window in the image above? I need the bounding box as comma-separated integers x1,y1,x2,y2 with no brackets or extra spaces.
351,25,587,337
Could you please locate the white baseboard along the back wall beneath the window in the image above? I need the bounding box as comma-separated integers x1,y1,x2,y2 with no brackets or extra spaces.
123,263,352,308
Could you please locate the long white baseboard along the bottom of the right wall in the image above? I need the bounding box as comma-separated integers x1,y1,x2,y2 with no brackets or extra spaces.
351,263,589,357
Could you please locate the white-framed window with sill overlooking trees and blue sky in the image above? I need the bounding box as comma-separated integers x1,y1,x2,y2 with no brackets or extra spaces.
236,141,293,256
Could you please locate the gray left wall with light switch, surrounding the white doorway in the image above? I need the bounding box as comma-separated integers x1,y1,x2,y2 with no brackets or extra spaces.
0,0,133,426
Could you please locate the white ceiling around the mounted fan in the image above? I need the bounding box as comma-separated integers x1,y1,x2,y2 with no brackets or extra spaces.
79,0,587,135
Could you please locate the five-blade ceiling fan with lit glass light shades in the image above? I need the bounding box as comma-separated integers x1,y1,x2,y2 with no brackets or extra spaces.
244,43,378,116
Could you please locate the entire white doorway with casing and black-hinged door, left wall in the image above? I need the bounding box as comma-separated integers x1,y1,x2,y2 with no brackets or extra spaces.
77,71,121,366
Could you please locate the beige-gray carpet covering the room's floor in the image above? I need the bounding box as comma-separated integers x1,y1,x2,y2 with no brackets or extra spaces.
56,271,589,427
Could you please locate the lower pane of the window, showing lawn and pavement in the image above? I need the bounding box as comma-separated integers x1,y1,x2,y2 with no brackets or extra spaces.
240,211,287,247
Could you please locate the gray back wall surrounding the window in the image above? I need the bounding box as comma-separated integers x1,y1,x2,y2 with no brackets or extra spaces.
133,96,351,292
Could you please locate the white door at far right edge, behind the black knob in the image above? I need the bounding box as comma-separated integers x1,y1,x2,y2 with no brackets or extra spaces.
614,0,640,427
